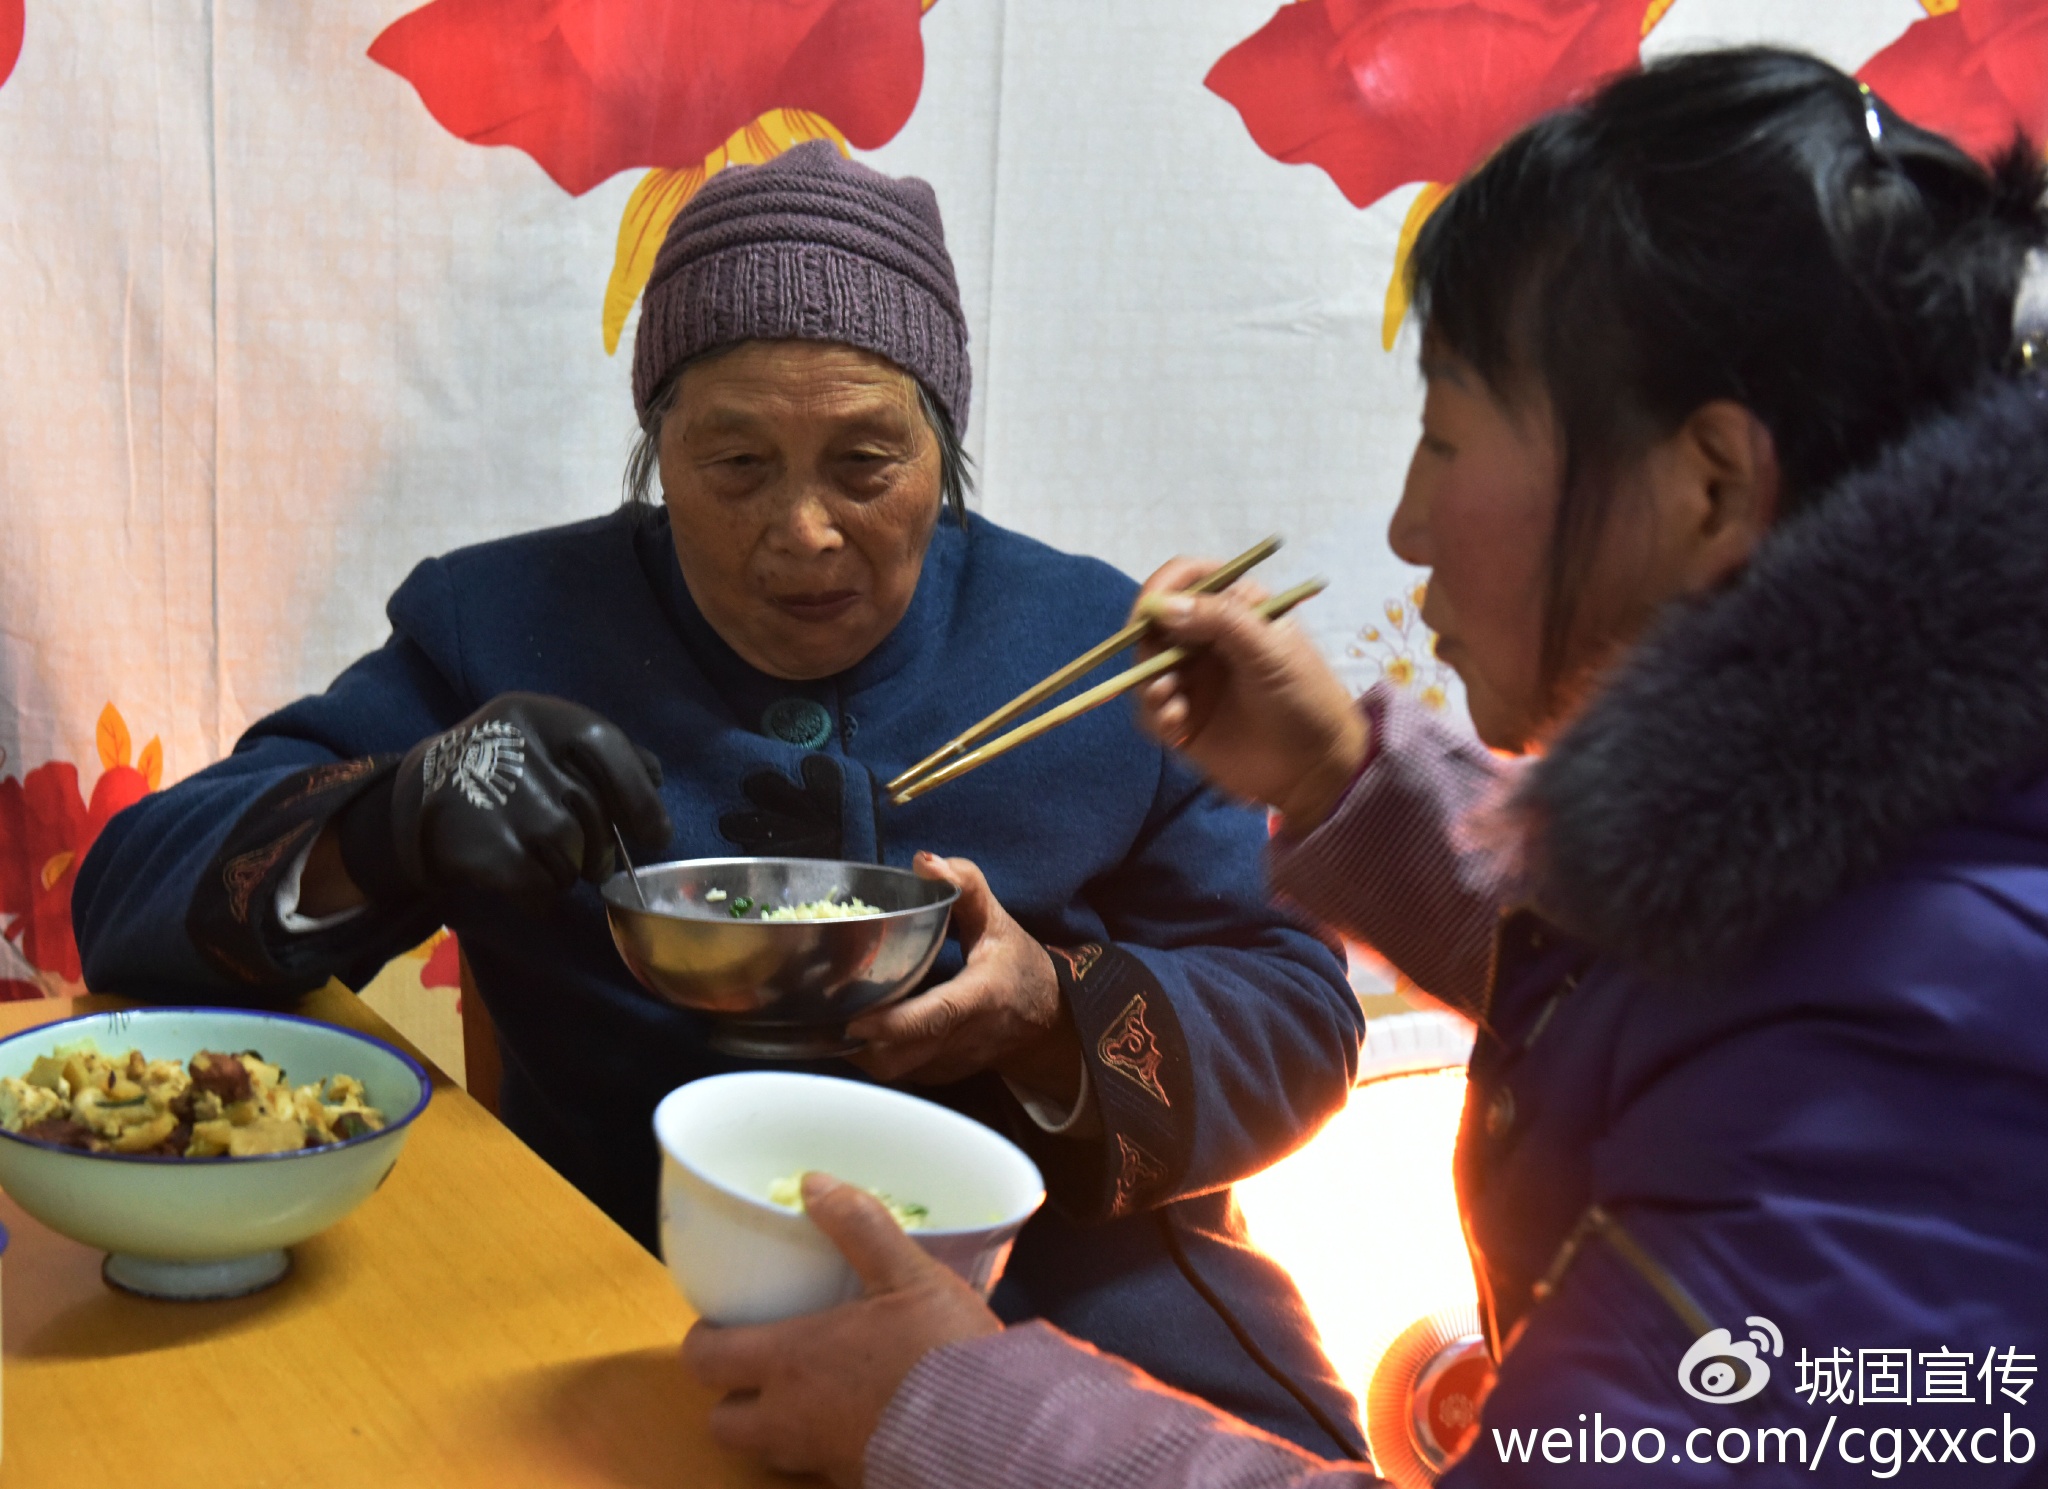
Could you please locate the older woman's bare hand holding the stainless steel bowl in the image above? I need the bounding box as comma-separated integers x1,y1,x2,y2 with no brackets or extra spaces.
846,854,1081,1100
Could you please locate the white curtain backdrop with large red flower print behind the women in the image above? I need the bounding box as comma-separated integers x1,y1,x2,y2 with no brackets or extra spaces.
0,0,2048,997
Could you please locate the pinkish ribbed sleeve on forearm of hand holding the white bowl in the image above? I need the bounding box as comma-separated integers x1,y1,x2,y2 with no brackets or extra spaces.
866,1323,1380,1489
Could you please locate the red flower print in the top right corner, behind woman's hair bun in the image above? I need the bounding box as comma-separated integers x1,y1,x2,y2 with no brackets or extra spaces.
1855,0,2048,158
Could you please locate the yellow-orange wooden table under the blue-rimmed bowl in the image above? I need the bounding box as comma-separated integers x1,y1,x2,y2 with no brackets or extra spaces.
0,985,793,1489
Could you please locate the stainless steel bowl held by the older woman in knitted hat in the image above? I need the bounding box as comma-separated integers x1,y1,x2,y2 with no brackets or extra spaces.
604,858,961,1059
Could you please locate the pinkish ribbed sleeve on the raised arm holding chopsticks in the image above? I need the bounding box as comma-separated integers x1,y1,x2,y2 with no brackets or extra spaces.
1270,682,1516,1014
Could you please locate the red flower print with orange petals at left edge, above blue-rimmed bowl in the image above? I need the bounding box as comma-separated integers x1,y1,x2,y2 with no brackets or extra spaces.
0,705,164,999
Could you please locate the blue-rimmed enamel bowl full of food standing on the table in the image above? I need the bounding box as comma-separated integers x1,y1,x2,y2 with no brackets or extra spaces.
0,1008,430,1299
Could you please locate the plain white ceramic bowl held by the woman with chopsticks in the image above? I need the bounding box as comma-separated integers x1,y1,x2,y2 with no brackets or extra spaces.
653,1071,1044,1323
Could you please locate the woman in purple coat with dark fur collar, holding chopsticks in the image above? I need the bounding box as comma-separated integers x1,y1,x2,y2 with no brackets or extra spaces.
688,51,2048,1489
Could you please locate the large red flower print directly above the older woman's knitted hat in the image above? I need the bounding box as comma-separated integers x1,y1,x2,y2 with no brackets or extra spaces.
372,0,924,197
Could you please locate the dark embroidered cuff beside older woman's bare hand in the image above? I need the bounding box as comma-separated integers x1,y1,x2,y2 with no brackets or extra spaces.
1024,942,1194,1219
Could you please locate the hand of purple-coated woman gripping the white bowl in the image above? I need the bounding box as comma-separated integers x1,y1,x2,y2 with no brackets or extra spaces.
682,1174,1004,1489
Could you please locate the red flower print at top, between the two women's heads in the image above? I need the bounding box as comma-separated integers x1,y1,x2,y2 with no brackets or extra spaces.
1208,0,1665,207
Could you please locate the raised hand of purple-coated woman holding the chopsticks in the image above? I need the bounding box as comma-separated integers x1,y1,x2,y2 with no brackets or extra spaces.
1133,559,1372,836
